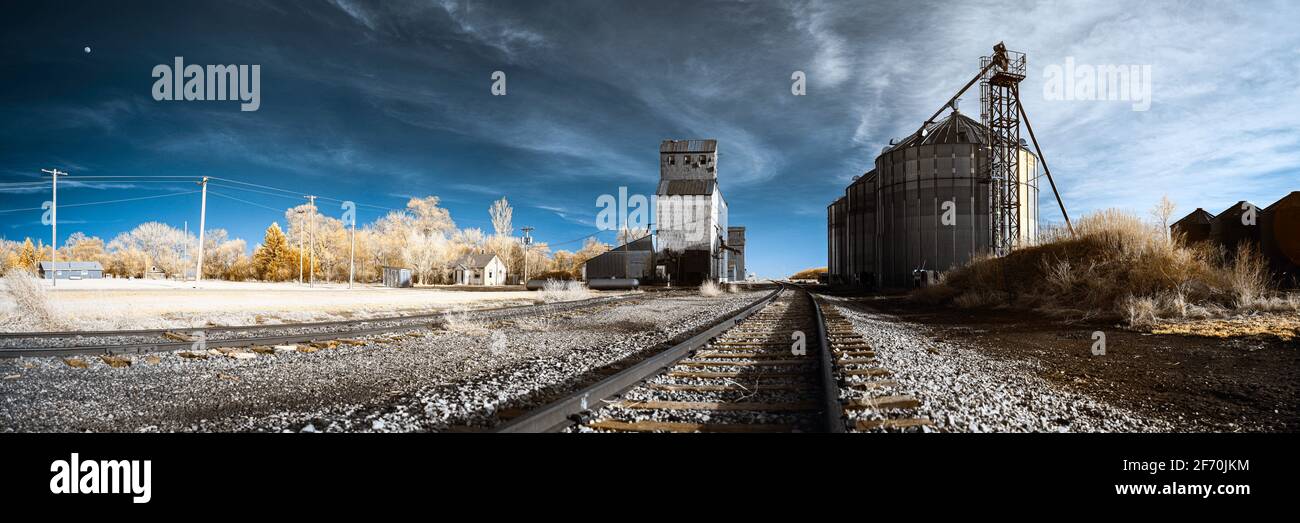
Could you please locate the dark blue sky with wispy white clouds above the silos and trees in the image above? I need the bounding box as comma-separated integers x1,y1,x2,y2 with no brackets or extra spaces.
0,0,1300,276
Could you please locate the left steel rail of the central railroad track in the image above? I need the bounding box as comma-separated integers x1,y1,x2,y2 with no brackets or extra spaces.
491,284,790,433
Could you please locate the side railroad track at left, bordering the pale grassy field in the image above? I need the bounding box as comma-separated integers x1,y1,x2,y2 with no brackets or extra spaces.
0,294,647,358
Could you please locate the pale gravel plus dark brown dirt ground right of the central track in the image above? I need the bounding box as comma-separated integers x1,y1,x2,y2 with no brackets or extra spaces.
827,297,1300,432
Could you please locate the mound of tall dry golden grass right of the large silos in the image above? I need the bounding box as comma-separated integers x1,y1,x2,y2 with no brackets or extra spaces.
913,209,1300,328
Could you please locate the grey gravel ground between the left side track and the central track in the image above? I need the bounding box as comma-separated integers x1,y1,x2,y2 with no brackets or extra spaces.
0,290,767,432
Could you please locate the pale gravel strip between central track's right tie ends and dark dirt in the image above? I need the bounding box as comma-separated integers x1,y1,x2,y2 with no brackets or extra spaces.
826,297,1197,432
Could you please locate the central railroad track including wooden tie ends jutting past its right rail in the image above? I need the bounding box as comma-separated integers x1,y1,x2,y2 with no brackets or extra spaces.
495,284,932,432
